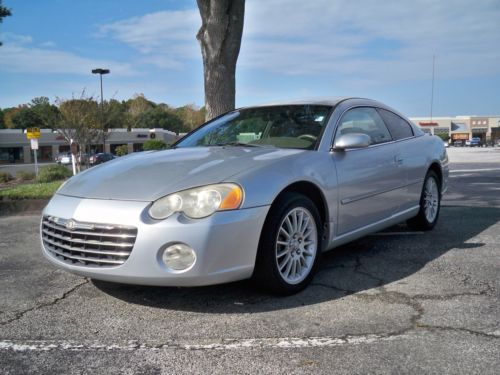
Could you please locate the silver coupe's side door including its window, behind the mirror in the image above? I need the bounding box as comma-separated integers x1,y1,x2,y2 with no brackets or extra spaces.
333,107,404,235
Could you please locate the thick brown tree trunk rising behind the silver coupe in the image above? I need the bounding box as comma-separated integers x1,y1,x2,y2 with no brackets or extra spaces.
196,0,245,121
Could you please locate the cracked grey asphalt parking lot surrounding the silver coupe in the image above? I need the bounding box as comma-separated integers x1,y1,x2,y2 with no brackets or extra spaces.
0,148,500,375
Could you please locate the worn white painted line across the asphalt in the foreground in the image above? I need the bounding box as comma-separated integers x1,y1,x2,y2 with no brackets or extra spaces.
0,334,406,352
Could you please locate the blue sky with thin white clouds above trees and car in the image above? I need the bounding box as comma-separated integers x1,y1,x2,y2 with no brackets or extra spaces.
0,0,500,116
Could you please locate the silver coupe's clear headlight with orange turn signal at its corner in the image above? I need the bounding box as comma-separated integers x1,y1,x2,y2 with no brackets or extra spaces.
149,184,243,220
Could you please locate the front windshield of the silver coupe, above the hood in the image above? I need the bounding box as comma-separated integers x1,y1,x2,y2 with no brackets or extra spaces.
175,105,332,150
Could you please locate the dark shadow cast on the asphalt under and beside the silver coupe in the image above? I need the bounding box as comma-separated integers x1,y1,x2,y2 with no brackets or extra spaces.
92,207,500,314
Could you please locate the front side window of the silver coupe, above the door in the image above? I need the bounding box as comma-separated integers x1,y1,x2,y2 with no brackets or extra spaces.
336,107,392,145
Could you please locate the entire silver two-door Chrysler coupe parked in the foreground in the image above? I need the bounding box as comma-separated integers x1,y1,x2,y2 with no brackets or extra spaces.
40,98,448,294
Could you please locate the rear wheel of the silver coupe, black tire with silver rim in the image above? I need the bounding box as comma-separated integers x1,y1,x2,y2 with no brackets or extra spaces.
406,170,441,230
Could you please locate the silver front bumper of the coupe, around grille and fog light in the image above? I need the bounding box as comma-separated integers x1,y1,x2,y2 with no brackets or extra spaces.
42,194,269,286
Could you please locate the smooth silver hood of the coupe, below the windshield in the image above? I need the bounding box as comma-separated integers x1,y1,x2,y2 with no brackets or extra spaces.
57,146,305,201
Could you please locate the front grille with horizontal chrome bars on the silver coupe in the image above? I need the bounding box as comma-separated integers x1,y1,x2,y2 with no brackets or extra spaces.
41,216,137,267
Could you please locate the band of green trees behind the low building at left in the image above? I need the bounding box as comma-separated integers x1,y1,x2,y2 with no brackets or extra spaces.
4,92,205,134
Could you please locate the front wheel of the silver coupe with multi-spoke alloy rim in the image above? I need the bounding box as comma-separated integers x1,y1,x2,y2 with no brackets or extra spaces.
252,193,322,295
